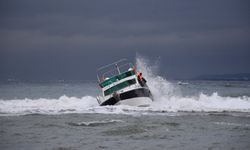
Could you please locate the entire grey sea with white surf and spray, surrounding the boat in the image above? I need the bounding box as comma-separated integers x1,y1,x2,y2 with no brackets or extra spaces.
0,59,250,150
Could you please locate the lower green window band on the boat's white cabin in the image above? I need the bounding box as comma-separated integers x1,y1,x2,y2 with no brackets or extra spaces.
104,79,136,96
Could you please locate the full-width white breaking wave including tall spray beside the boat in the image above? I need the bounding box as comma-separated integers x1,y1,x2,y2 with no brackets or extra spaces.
0,57,250,116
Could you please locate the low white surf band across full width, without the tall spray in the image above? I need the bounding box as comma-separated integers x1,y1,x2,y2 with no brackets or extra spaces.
0,93,250,116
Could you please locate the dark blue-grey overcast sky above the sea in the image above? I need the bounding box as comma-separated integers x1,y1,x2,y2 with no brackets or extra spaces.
0,0,250,80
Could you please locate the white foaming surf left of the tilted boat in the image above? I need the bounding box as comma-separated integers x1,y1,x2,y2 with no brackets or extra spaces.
0,96,97,115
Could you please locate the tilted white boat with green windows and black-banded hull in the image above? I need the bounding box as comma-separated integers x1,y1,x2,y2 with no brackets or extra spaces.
96,59,153,107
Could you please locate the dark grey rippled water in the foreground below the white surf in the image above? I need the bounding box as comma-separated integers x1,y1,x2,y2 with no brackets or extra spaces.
0,113,250,150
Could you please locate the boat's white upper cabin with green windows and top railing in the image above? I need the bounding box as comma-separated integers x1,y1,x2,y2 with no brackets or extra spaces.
97,59,146,104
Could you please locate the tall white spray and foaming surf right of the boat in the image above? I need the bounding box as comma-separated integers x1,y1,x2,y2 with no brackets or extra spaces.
136,56,250,112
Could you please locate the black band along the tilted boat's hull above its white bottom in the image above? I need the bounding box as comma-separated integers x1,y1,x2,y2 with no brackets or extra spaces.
100,88,153,106
